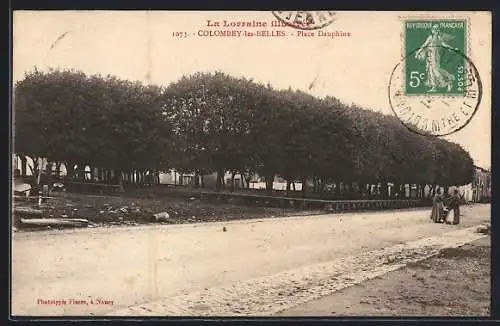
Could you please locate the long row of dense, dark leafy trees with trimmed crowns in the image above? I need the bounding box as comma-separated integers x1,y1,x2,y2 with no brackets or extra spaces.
14,70,474,196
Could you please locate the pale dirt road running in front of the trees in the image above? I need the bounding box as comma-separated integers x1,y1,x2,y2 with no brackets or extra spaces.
12,205,490,316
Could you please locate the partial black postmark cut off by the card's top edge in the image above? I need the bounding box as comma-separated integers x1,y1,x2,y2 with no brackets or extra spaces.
273,11,337,30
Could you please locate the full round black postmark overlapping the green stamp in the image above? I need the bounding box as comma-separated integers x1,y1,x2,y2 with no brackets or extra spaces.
389,46,482,136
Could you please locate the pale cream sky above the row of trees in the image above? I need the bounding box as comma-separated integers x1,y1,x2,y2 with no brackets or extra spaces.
13,11,491,168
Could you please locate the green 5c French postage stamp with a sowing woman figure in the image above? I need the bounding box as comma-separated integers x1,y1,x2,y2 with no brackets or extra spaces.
404,19,467,96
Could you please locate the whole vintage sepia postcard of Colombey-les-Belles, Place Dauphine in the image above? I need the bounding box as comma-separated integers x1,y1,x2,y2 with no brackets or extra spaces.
10,10,492,317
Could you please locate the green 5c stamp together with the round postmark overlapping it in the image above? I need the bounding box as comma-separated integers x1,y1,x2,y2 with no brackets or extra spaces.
389,19,482,136
